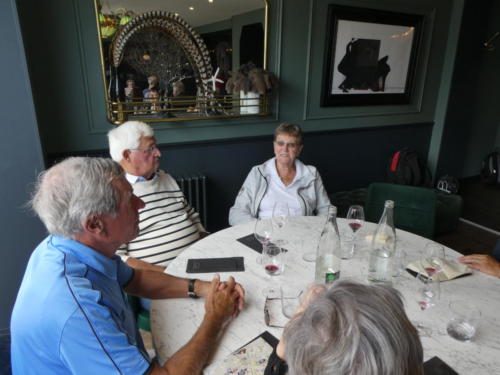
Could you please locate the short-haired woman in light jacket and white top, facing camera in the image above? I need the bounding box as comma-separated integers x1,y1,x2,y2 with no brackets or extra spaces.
229,123,330,225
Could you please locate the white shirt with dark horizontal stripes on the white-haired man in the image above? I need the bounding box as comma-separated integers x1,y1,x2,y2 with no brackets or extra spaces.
117,170,205,267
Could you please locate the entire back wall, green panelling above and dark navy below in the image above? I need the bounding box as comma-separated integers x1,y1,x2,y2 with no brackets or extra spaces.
18,0,470,230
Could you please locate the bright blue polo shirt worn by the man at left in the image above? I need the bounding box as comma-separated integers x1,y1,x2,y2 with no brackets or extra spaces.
11,235,151,375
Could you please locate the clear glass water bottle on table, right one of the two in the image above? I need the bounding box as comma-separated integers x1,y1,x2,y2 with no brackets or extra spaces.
368,200,396,283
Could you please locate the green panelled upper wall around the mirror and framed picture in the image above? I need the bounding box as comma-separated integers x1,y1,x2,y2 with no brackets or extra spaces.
18,0,457,153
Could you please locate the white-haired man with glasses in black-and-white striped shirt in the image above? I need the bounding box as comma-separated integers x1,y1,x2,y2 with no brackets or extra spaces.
108,121,206,280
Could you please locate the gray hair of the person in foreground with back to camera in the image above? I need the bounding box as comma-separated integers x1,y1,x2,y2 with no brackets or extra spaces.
283,281,423,375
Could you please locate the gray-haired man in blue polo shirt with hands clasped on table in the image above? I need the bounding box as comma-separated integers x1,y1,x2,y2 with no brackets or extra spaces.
11,157,244,374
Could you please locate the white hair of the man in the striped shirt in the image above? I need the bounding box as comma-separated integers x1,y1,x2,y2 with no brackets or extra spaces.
108,121,154,163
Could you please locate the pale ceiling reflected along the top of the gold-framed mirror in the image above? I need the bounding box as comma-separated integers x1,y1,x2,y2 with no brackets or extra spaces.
101,0,264,27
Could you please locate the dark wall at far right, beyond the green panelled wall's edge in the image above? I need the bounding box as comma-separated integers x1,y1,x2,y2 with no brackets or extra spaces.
438,0,500,177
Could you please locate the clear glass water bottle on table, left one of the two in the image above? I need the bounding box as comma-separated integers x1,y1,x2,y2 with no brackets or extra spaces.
315,206,341,284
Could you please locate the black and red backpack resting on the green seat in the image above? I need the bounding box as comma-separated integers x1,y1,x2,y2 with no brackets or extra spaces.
387,147,432,187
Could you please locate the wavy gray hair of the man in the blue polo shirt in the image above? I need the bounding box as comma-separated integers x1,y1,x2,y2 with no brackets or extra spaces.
30,157,124,238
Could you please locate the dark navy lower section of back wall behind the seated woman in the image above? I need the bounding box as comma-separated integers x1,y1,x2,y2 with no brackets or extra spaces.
50,123,432,232
